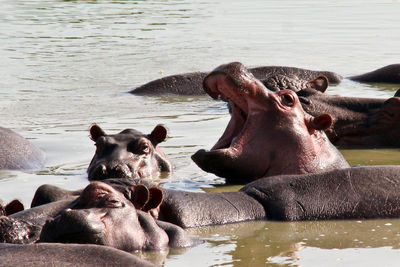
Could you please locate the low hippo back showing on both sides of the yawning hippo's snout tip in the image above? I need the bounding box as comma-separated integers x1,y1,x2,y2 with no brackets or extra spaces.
130,66,342,95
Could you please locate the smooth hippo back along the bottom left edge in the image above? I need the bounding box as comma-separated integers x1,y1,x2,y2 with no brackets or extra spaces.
0,243,155,267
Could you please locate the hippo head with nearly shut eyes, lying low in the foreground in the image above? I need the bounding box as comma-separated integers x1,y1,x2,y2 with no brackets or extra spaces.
40,182,192,252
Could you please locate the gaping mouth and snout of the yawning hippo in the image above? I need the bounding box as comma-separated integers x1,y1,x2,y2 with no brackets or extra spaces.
192,62,280,182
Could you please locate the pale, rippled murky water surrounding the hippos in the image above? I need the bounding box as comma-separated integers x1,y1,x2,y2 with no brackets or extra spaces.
0,0,400,267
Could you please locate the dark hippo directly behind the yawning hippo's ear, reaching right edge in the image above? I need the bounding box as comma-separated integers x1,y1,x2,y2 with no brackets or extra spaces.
297,88,400,148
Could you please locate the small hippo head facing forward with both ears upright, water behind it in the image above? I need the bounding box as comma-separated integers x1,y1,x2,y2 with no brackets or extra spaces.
87,124,172,180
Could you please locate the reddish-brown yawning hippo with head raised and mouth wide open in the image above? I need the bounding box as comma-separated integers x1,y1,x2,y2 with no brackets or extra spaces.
192,62,349,184
